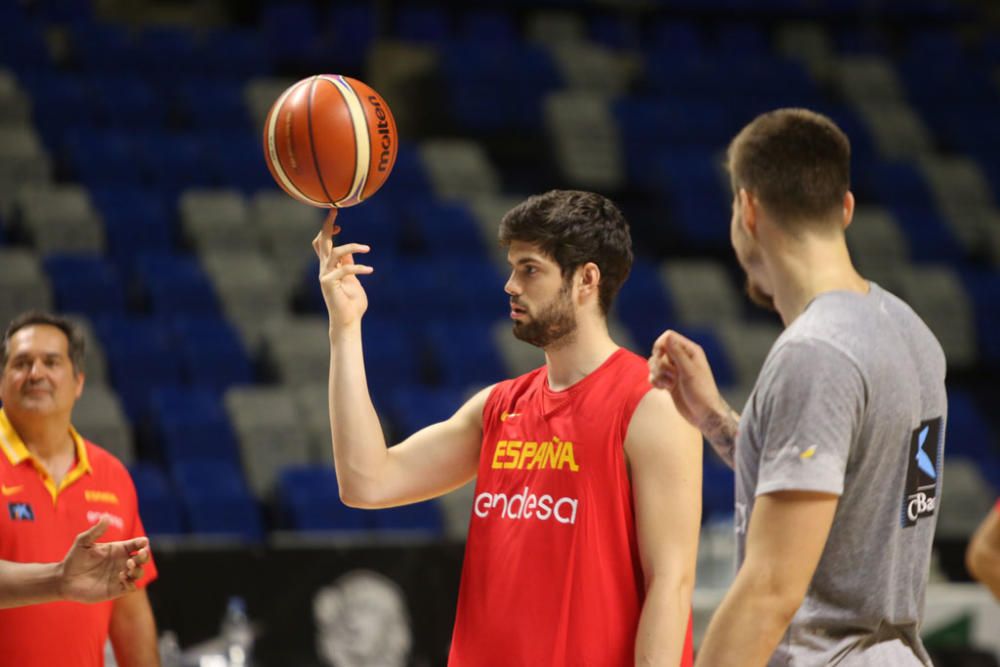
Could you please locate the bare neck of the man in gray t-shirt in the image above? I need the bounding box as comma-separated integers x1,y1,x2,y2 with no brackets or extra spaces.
768,235,870,327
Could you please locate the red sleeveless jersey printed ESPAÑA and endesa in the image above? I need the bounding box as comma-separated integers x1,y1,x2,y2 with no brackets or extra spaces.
448,349,692,667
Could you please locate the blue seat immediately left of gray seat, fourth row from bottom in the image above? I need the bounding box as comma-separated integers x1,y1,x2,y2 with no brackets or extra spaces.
134,252,220,316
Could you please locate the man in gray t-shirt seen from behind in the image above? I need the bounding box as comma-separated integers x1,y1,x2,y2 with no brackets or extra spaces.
650,109,947,667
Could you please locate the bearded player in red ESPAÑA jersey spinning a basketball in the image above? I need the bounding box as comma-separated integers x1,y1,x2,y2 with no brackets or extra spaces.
313,191,701,667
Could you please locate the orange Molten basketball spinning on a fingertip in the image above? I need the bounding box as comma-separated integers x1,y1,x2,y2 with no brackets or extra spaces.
264,74,399,208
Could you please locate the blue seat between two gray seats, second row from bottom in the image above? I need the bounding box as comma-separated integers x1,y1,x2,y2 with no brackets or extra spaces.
149,386,240,466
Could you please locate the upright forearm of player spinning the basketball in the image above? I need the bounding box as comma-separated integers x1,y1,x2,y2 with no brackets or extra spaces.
329,328,388,504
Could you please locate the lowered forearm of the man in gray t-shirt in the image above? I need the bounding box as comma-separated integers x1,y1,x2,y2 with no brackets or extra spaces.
696,575,797,667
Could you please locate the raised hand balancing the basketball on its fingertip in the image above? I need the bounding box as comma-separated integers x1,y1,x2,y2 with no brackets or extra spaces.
313,209,374,327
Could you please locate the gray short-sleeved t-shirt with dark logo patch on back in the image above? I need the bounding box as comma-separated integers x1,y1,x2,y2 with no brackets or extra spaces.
735,283,947,667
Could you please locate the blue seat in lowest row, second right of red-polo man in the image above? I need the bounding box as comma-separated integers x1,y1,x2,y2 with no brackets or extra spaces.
172,461,264,542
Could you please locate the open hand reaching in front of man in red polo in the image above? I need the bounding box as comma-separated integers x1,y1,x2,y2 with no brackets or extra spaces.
59,517,149,602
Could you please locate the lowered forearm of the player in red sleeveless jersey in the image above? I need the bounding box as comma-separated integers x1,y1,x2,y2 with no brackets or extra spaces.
635,581,692,667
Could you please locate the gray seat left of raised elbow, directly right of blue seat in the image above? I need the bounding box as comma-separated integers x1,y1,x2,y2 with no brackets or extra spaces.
224,387,310,498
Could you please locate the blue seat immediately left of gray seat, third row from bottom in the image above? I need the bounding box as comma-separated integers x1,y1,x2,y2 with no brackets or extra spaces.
171,316,254,392
